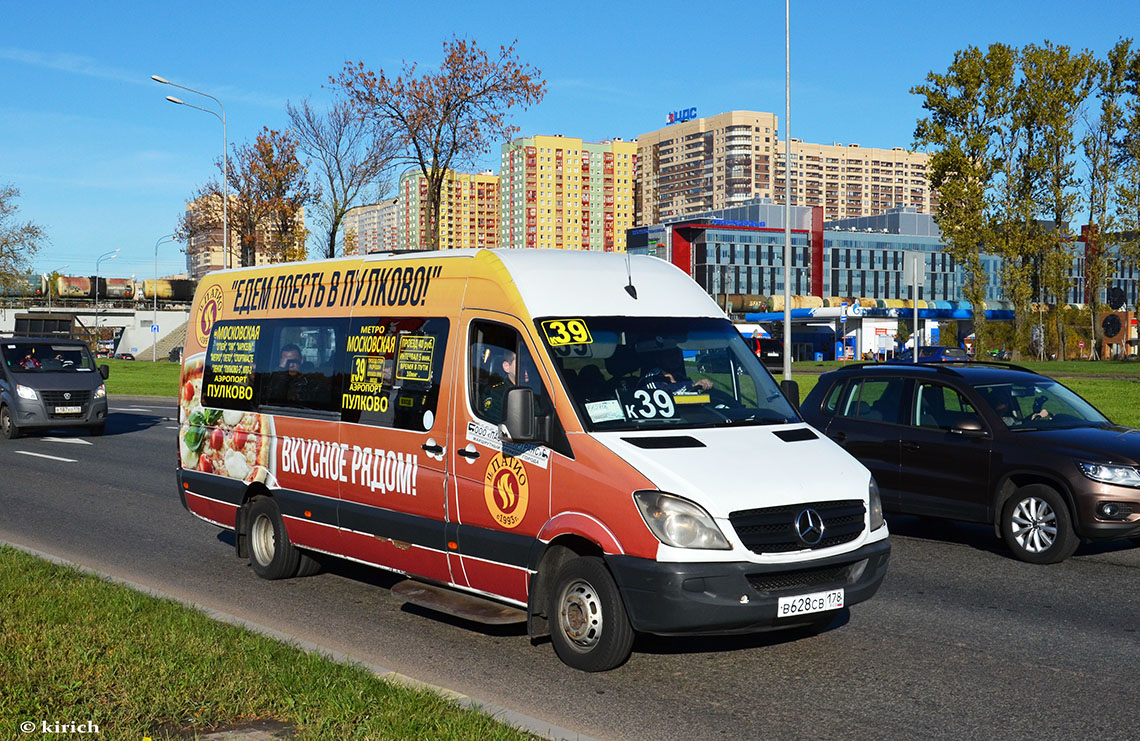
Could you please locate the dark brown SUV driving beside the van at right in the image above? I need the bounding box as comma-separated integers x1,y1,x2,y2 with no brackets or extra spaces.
800,363,1140,563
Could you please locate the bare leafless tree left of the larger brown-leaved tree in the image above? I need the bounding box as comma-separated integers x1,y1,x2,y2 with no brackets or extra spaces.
286,98,398,258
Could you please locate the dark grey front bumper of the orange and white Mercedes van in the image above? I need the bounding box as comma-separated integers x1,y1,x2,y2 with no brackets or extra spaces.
605,539,890,635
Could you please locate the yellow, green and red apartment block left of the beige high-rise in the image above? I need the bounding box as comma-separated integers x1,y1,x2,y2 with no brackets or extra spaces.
499,135,637,252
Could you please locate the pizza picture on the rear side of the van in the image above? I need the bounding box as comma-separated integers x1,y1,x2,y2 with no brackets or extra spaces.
178,353,272,483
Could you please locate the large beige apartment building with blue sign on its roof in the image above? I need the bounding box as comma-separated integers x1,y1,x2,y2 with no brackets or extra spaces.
635,111,935,226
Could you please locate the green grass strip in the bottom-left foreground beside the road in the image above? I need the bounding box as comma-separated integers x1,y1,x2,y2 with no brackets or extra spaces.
0,547,532,740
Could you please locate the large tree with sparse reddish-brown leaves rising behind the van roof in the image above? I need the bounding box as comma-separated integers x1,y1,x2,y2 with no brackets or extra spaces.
331,38,546,249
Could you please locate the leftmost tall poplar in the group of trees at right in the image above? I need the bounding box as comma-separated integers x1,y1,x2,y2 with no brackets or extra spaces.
911,44,1009,355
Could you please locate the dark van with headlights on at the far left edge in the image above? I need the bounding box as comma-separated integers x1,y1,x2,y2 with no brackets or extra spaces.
0,337,109,439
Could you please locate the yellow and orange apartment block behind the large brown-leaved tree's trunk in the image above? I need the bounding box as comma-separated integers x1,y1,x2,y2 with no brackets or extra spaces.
396,168,499,250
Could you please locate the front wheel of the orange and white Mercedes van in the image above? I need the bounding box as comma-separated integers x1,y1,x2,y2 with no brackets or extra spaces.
547,556,634,671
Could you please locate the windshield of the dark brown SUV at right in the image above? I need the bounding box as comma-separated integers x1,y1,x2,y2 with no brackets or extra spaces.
975,378,1112,431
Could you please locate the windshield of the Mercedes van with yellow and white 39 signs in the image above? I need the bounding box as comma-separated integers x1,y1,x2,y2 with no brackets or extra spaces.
535,317,799,431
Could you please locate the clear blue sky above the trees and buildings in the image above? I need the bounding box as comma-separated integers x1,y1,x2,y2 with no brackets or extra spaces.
0,0,1140,278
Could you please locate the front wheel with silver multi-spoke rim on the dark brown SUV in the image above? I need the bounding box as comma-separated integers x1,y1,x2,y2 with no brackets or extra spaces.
1001,483,1081,563
